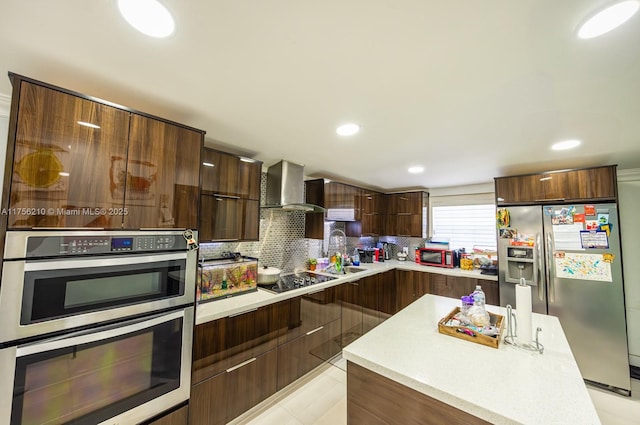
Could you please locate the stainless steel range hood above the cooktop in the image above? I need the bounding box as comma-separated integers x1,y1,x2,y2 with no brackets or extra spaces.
262,160,325,212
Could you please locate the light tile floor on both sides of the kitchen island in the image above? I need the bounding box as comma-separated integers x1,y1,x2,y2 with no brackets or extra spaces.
230,356,640,425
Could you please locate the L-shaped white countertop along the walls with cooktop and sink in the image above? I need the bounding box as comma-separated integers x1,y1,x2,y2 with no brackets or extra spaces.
196,260,498,325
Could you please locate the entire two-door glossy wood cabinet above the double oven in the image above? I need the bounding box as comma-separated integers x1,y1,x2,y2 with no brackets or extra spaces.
2,73,204,229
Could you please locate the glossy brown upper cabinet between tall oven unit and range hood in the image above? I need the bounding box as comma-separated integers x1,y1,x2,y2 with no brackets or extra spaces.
199,148,262,241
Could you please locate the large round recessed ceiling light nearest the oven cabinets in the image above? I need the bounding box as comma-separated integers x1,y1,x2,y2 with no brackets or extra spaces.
118,0,175,38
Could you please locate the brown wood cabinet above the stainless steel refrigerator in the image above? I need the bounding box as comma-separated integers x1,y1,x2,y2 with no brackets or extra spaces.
494,165,618,205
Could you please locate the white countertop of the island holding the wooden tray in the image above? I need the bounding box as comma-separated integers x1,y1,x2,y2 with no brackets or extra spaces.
342,295,600,425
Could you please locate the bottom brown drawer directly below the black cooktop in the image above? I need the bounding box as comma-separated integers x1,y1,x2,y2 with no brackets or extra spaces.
274,319,342,391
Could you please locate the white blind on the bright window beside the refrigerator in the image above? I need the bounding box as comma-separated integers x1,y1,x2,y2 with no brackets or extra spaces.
431,193,496,252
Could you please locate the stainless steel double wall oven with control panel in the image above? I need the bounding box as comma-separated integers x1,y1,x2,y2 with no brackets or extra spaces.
0,230,197,425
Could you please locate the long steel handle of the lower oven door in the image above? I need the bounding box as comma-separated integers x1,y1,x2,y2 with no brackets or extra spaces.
16,307,192,357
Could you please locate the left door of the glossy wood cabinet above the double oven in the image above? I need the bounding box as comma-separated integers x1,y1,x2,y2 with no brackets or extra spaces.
3,80,130,229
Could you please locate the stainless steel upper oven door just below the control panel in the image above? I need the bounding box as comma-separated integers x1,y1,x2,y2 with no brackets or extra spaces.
0,251,197,344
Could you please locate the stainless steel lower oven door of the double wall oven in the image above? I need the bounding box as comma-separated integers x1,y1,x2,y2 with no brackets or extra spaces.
0,307,194,425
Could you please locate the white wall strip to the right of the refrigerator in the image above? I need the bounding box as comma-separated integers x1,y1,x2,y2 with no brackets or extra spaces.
618,170,640,367
